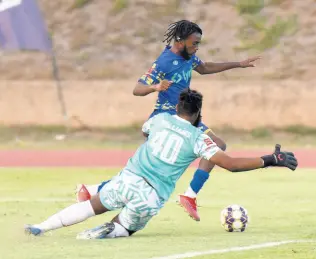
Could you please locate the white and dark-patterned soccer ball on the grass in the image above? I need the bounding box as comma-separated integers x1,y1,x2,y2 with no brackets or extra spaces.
221,204,249,232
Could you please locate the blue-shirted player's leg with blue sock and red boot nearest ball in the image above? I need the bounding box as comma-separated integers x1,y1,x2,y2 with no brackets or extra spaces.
179,123,226,221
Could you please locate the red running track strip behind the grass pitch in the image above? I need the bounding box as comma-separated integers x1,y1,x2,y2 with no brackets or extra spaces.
0,149,316,168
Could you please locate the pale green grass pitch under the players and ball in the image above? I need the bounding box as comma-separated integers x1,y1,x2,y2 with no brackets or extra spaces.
0,168,316,259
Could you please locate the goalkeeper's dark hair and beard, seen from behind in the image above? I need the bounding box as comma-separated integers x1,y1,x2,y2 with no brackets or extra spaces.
178,88,203,126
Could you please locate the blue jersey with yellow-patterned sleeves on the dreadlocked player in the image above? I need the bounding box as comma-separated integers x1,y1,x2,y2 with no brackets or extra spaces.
138,46,202,111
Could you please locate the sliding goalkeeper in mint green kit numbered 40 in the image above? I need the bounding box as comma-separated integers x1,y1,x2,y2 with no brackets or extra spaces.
25,89,297,239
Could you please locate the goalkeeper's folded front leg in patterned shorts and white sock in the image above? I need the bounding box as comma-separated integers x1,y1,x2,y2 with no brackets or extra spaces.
77,172,164,239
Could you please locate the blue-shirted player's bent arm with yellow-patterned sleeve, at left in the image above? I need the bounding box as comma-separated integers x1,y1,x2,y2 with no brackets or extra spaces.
133,61,172,96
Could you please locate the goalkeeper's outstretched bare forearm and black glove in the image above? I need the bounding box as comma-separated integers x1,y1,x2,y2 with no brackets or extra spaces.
209,145,297,172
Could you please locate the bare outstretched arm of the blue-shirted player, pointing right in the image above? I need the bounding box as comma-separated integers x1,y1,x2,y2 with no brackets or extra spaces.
194,56,260,75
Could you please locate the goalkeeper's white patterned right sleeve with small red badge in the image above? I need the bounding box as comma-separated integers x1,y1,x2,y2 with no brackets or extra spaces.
194,133,220,160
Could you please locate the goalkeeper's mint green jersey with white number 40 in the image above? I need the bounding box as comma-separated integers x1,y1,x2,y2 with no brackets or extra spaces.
125,113,219,200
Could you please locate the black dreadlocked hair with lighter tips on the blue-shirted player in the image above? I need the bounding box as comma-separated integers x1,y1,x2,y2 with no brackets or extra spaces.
163,20,202,45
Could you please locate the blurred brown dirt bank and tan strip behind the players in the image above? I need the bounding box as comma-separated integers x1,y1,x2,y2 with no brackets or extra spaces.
0,0,316,147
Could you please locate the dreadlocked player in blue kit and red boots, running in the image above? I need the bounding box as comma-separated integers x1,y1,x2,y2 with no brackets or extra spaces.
77,20,260,221
